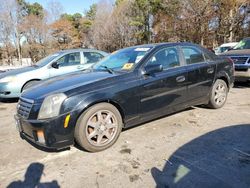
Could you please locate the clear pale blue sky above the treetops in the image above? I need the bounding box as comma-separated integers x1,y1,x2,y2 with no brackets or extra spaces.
26,0,99,14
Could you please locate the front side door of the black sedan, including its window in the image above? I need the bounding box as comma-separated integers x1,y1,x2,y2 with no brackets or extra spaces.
140,47,187,120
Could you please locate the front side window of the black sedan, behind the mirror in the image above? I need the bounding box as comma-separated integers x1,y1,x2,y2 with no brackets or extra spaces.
147,47,180,69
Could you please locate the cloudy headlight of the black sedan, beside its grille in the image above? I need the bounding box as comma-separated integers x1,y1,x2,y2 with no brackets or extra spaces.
38,93,67,119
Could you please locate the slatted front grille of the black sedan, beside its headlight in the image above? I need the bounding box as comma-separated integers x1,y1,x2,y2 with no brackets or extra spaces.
17,98,34,119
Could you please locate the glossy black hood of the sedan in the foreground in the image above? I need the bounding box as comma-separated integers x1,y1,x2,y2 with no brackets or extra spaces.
22,71,116,101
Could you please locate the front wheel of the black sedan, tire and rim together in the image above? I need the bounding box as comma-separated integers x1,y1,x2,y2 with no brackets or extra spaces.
74,103,123,152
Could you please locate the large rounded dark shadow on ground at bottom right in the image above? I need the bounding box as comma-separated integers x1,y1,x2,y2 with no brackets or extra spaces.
151,124,250,188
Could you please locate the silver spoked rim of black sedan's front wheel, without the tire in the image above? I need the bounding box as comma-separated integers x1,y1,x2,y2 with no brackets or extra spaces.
86,110,118,146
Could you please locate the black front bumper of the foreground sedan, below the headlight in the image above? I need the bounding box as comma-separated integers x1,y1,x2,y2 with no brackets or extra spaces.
15,111,76,150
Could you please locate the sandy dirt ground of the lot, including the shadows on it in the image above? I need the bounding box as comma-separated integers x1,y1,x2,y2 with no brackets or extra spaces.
0,84,250,188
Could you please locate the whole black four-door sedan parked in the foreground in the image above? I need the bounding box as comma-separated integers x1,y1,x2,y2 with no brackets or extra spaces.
15,43,234,152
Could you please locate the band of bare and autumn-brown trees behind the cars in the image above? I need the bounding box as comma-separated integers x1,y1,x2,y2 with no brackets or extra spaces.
0,0,250,64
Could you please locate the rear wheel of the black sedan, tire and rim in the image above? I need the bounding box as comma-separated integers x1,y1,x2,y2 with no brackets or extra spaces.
208,79,228,109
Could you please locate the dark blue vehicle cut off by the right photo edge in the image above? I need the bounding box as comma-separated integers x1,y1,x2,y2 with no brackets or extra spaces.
221,38,250,81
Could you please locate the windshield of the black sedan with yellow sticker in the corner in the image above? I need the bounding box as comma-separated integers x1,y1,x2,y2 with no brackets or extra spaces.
93,47,152,71
